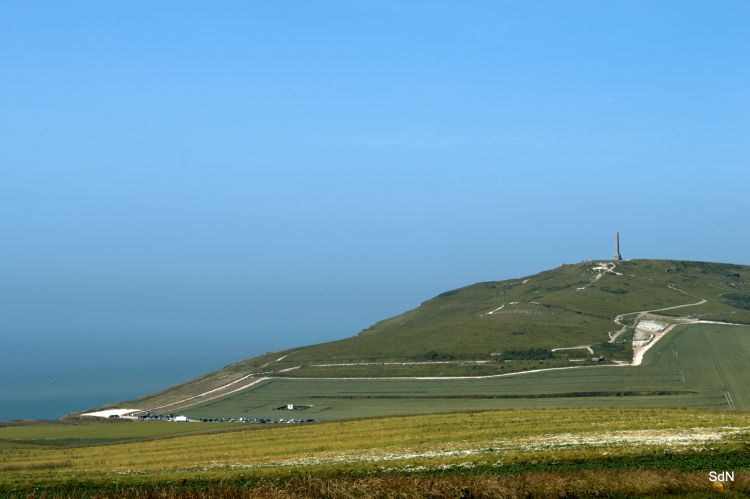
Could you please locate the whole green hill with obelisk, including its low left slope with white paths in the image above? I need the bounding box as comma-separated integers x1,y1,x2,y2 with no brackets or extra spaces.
111,260,750,411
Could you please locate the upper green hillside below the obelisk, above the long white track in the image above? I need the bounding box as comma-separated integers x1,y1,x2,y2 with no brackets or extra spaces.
229,260,750,375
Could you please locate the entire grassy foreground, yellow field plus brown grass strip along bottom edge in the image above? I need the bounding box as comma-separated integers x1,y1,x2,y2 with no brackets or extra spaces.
0,409,750,497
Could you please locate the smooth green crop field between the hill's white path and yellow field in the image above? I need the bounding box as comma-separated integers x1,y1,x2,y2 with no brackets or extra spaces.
175,324,750,420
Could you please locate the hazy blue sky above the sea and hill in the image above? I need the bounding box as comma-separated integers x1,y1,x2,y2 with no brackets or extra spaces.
0,0,750,354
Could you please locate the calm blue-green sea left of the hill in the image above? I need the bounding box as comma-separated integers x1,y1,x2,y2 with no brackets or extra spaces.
0,337,262,420
